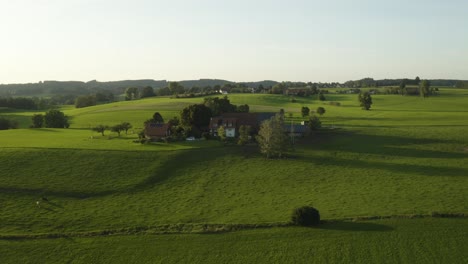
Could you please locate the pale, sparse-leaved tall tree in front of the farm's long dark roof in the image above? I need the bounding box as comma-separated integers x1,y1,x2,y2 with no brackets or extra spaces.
257,115,288,158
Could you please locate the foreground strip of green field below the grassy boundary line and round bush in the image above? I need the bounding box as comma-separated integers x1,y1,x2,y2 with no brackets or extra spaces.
0,219,468,263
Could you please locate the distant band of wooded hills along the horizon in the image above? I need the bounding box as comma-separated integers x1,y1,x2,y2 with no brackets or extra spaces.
0,77,468,109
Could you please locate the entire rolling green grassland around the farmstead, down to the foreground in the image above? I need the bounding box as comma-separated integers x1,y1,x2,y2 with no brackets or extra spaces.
0,89,468,263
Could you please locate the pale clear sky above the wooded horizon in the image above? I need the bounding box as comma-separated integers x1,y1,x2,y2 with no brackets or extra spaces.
0,0,468,83
